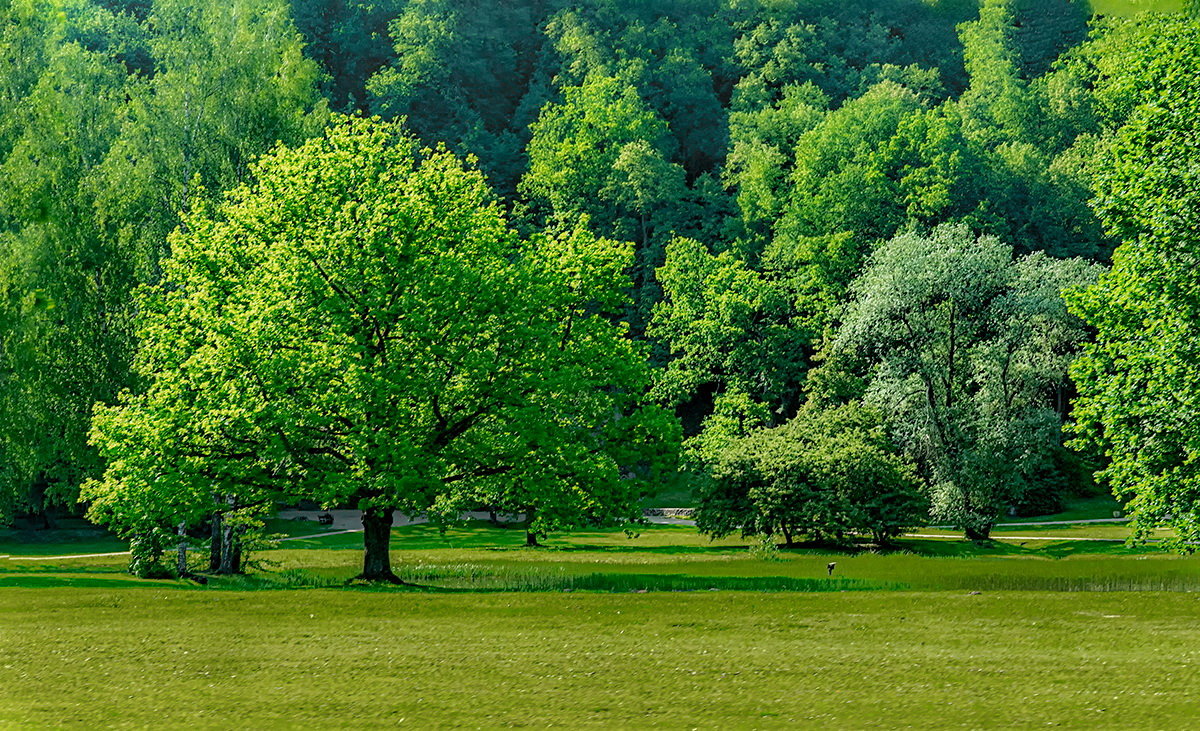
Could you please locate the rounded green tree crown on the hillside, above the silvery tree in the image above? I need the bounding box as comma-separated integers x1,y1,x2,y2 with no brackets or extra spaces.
769,82,980,296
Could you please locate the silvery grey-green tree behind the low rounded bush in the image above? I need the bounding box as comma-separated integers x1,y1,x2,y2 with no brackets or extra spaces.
828,226,1096,538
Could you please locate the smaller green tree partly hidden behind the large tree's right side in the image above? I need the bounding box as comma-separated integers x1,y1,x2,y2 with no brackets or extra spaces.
450,229,679,540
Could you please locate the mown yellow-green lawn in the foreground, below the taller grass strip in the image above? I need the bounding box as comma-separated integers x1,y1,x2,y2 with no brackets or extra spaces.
0,588,1200,729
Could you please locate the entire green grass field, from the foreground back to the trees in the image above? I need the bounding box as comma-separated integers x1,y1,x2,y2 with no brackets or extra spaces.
0,519,1200,729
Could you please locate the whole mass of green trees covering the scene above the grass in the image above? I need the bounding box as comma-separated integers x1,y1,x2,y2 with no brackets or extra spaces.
0,0,1200,579
